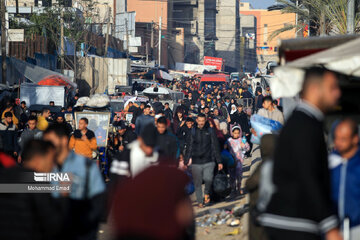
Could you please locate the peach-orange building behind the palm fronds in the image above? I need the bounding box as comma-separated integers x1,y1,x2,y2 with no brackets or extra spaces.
240,2,296,69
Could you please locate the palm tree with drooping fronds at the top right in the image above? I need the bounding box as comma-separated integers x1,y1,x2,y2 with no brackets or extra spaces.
269,0,360,39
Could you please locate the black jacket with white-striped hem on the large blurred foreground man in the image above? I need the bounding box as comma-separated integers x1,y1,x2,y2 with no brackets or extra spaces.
260,103,338,234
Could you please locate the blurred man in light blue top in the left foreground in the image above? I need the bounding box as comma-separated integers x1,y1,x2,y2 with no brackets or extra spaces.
44,124,105,240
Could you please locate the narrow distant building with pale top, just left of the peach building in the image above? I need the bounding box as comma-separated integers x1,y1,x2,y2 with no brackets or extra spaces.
240,15,257,72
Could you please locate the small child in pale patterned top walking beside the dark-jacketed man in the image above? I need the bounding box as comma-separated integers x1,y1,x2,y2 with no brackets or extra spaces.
227,126,250,195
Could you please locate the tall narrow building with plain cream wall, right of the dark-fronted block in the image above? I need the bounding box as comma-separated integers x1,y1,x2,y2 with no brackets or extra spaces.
215,0,240,72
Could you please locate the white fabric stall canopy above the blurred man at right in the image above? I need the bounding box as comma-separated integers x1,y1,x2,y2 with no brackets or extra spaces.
270,38,360,98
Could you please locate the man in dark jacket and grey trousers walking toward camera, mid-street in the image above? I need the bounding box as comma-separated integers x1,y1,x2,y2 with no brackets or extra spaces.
185,114,223,207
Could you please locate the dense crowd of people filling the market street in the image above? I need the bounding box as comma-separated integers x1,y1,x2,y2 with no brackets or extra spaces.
0,68,360,240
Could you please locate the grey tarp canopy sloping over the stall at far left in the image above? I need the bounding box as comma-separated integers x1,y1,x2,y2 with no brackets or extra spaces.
10,58,77,88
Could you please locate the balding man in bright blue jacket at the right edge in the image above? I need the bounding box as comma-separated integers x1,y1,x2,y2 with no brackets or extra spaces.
329,119,360,239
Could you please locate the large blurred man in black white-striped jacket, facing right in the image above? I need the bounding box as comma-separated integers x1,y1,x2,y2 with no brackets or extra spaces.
259,67,341,240
